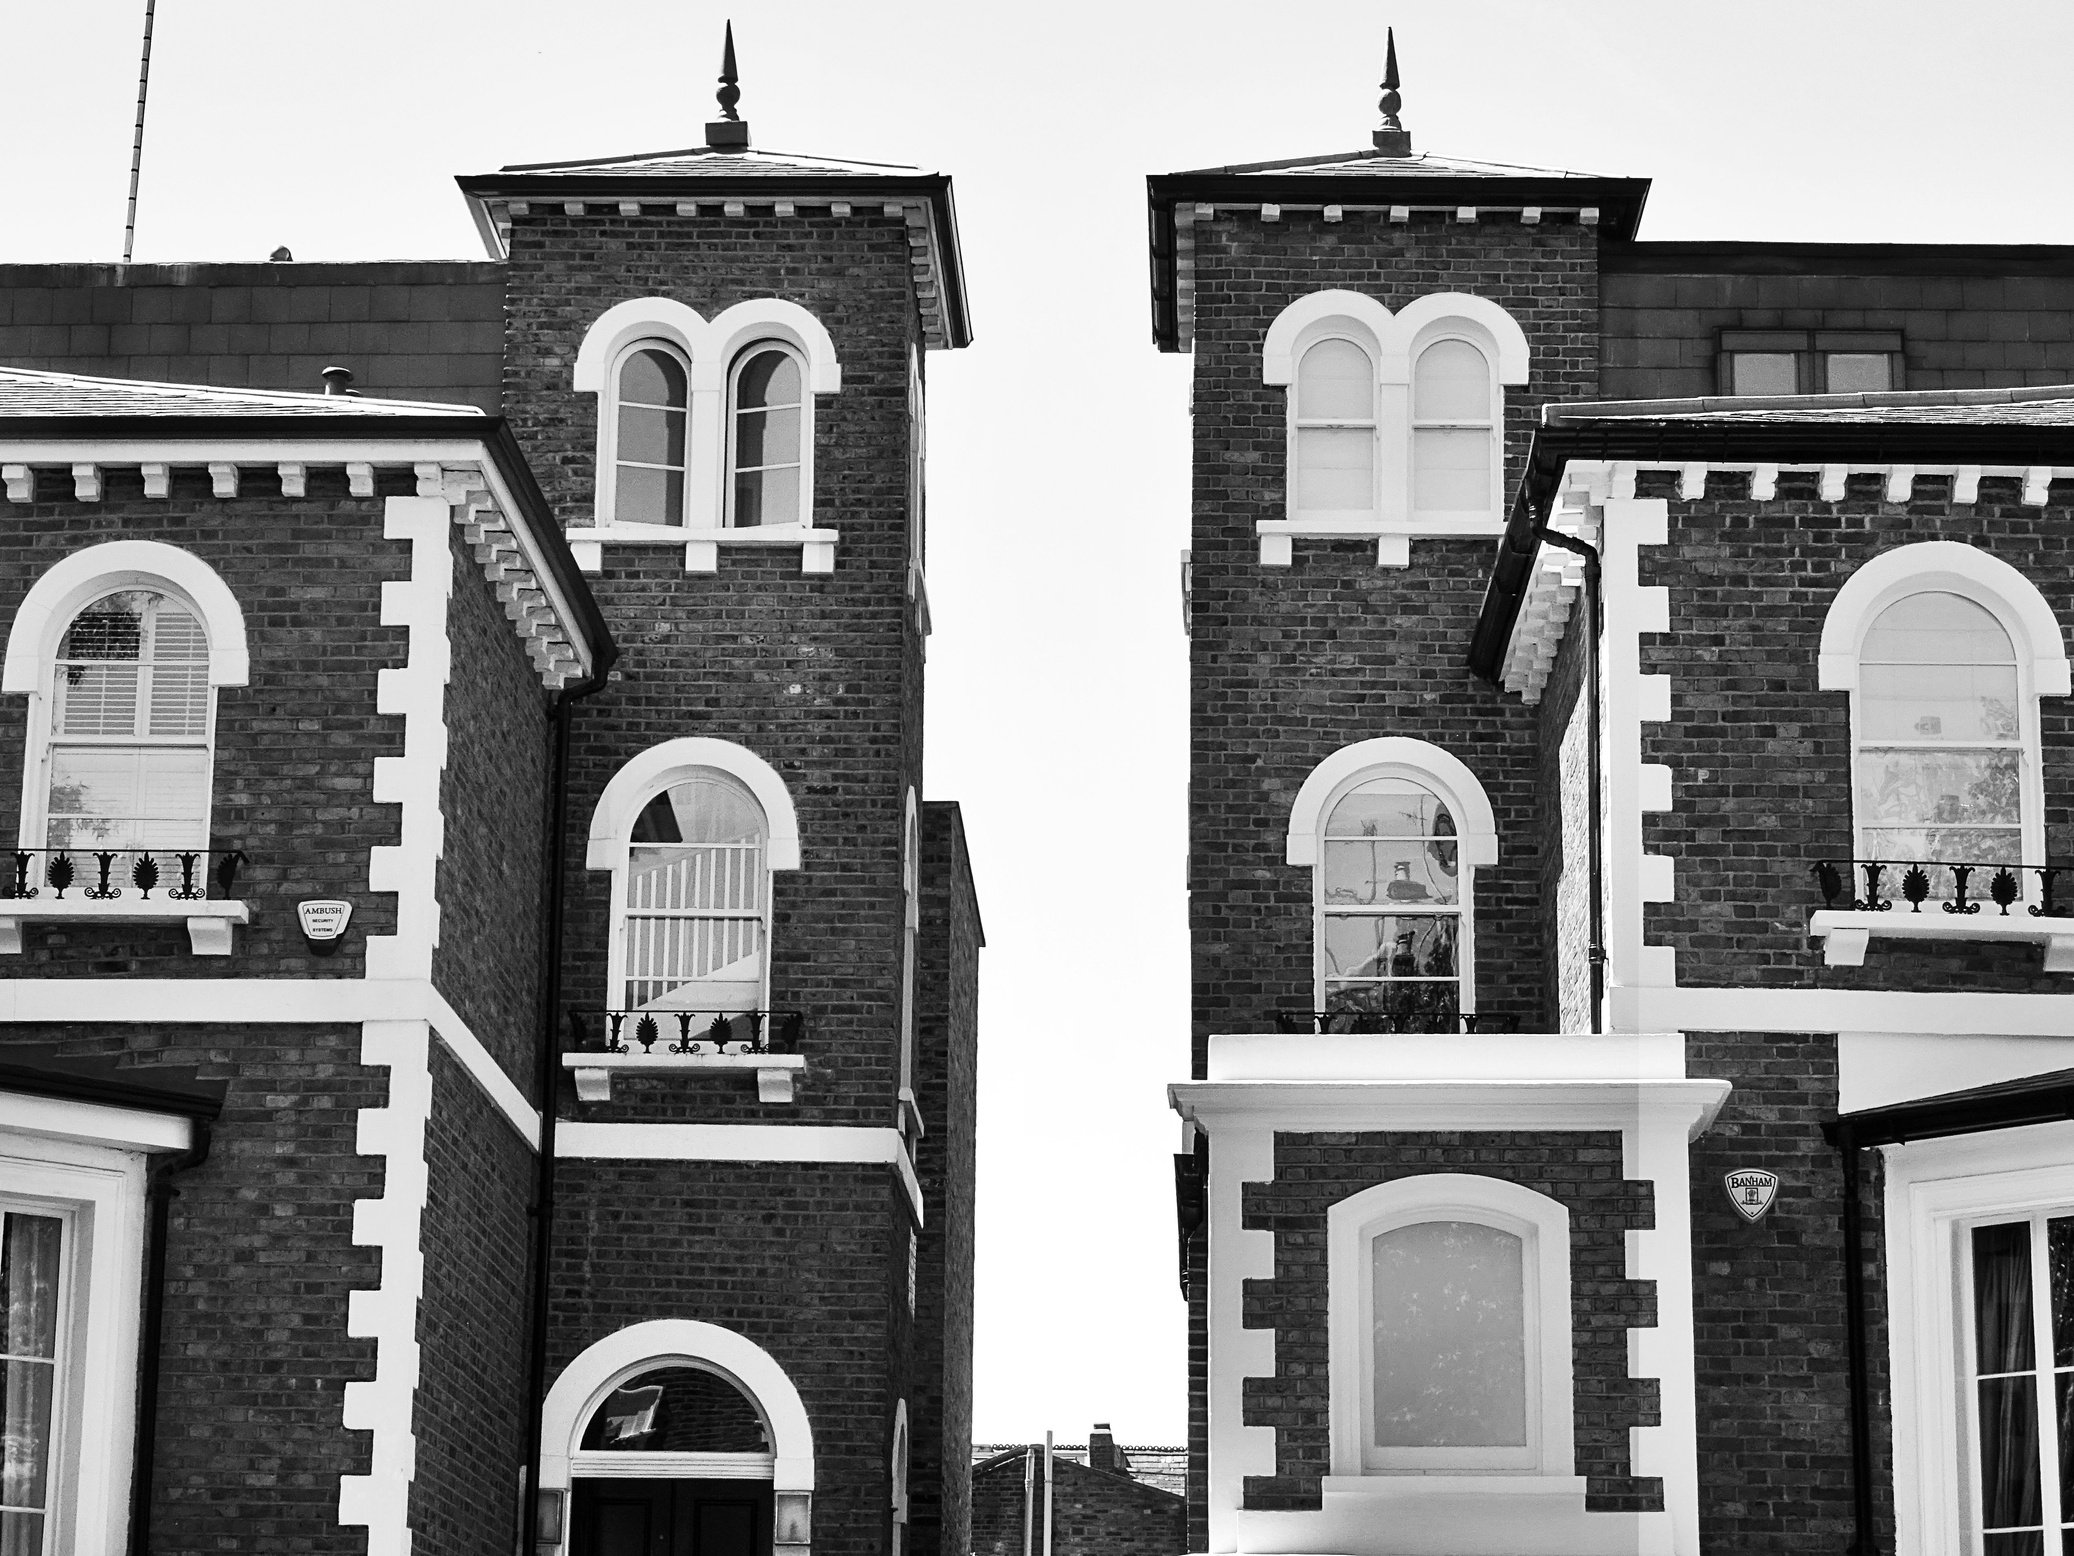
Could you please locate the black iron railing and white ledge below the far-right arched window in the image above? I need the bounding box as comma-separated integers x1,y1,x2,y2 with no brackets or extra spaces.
1809,859,2074,973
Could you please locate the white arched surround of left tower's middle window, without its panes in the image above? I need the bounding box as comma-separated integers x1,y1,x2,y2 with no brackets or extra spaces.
585,737,801,1024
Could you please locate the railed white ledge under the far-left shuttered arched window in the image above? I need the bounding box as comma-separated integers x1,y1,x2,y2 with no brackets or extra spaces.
0,849,251,956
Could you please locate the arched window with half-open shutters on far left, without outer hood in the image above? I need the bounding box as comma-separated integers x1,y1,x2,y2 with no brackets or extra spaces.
39,589,216,849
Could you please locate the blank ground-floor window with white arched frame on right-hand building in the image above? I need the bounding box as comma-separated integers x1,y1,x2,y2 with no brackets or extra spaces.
1325,1172,1574,1475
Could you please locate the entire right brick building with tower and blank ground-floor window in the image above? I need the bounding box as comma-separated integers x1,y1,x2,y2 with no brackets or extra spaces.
1149,48,2074,1556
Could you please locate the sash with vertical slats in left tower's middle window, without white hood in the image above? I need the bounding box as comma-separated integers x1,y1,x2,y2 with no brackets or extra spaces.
616,768,769,1015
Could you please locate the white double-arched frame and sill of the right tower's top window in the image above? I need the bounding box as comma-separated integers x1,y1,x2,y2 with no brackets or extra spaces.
1257,288,1531,566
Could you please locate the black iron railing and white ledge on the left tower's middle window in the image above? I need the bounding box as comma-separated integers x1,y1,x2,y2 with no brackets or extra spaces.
562,1010,807,1102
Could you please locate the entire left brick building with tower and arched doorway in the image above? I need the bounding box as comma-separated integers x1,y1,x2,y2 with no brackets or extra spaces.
0,79,981,1556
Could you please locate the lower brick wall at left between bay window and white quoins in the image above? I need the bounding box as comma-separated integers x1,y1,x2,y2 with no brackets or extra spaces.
0,1023,388,1554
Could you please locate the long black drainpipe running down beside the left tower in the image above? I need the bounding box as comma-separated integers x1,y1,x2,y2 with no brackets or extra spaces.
519,672,606,1556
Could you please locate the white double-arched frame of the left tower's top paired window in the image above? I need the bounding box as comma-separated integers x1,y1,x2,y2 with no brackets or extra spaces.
570,297,842,543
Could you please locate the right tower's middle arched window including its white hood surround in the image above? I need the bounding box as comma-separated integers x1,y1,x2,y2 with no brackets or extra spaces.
1288,737,1497,1031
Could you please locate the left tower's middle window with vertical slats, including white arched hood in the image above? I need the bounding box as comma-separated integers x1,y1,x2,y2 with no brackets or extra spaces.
587,737,798,1025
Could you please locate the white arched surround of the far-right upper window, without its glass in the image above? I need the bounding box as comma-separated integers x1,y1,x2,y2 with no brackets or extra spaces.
1817,541,2070,896
